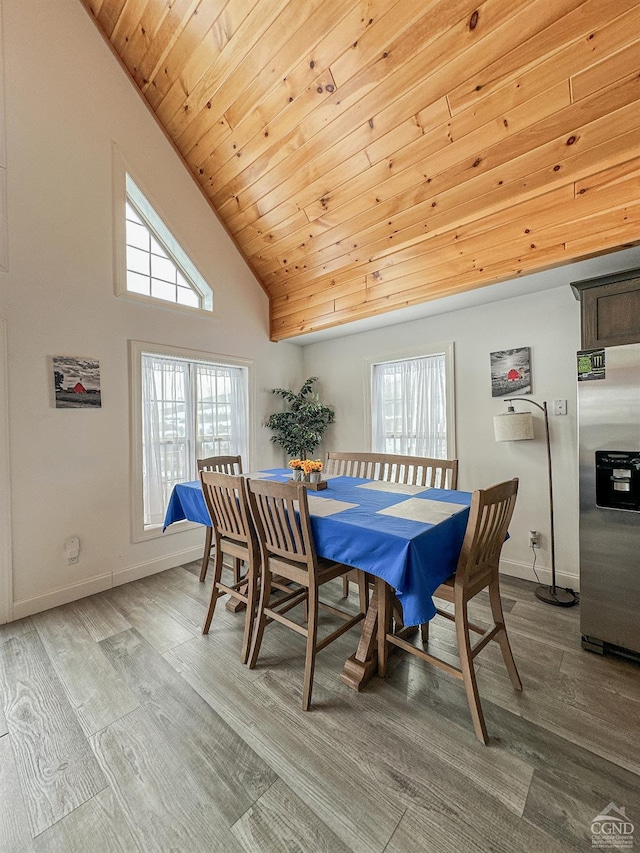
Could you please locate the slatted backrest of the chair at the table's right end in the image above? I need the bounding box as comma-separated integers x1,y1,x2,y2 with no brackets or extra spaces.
455,477,518,585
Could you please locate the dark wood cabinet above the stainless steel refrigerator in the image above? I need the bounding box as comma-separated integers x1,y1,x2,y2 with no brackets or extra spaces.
571,269,640,349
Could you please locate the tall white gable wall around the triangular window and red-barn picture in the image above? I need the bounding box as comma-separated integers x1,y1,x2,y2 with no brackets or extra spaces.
0,0,302,618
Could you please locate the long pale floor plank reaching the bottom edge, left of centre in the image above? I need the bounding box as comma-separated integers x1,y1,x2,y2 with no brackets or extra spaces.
90,708,246,853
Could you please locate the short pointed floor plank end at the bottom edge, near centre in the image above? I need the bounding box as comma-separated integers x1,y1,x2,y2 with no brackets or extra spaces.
233,779,351,853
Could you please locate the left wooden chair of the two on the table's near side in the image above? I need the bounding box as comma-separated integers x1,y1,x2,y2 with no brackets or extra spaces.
200,471,260,663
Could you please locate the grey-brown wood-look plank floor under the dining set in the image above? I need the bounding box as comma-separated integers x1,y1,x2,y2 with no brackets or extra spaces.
0,563,640,853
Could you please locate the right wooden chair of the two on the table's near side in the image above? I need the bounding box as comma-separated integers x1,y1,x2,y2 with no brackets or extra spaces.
249,480,365,711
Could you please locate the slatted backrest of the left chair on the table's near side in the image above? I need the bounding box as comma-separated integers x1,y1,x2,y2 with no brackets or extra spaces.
200,471,252,544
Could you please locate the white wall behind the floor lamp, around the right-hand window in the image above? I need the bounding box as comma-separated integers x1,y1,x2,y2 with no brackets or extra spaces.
304,249,640,589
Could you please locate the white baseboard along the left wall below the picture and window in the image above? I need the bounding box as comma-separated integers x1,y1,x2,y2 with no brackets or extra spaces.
13,548,202,620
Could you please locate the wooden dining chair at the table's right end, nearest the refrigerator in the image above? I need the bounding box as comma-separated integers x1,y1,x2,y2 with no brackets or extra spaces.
377,478,522,744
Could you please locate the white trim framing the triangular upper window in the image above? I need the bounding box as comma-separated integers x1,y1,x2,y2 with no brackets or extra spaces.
112,142,217,319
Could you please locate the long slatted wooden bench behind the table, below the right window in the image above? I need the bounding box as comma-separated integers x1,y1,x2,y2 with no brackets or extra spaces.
336,451,458,598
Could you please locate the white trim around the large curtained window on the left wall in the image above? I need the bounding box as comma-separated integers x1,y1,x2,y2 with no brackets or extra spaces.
129,340,256,542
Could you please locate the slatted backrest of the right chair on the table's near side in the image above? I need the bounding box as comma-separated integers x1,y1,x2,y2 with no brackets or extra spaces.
248,480,317,573
